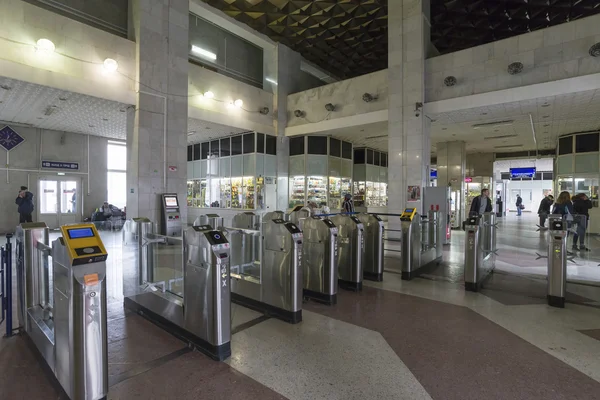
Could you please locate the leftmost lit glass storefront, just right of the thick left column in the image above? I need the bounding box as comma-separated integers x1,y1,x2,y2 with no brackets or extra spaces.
187,132,277,210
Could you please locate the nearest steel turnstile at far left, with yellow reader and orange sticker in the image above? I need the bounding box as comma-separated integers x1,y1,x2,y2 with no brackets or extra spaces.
17,224,108,400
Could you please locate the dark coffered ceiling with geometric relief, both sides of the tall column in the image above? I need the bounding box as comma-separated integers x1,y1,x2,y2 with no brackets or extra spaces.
202,0,600,79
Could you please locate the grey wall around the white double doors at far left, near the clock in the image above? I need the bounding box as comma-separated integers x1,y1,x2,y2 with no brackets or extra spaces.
0,124,108,233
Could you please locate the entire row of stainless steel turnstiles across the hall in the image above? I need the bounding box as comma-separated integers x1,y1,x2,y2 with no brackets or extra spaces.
11,208,566,399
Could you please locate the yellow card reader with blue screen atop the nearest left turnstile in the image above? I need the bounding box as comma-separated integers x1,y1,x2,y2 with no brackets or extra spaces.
60,224,107,265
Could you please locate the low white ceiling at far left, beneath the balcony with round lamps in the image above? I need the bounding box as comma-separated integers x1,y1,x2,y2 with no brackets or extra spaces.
0,77,128,139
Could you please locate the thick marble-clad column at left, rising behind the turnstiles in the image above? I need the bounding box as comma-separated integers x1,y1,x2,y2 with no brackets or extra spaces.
127,0,189,224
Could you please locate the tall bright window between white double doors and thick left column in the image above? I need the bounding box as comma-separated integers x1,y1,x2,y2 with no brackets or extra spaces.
106,142,126,209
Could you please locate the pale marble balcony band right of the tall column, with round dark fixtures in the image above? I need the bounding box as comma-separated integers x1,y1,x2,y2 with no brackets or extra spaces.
425,15,600,102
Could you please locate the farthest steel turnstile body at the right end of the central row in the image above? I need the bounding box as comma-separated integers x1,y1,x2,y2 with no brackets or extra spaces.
357,214,384,282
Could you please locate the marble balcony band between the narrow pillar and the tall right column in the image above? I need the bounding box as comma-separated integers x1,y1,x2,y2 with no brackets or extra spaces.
287,70,388,126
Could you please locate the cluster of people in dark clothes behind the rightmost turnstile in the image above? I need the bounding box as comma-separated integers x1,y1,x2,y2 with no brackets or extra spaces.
538,191,592,251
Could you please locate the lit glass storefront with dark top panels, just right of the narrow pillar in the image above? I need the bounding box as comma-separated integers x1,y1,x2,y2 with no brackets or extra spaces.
289,136,352,212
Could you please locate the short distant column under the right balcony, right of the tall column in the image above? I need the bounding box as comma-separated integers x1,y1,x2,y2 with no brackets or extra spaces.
437,141,467,193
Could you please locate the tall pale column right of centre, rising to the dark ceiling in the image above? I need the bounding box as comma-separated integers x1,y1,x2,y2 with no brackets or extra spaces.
388,0,431,223
